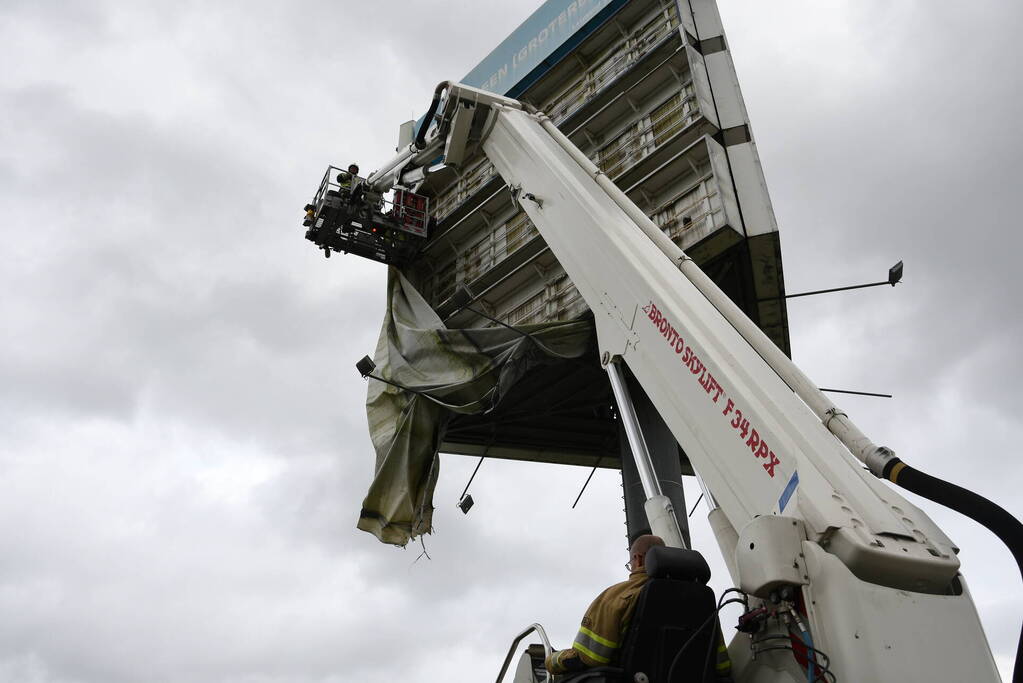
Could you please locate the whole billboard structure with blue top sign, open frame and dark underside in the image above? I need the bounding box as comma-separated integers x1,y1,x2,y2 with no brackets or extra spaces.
363,0,789,536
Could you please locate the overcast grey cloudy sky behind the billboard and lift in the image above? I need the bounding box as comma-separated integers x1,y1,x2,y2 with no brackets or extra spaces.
0,0,1023,683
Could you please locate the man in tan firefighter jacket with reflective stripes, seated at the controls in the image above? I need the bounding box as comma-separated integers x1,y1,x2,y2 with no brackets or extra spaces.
544,534,731,681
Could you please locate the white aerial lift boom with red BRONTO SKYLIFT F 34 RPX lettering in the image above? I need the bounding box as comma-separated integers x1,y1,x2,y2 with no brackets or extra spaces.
347,83,1023,683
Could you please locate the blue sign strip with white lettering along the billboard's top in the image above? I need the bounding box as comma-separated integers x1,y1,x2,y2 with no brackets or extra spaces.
461,0,628,97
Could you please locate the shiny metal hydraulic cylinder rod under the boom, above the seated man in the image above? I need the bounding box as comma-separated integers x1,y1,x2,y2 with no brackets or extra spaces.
608,360,686,548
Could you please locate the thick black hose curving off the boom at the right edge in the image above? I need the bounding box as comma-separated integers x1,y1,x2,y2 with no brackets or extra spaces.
882,458,1023,683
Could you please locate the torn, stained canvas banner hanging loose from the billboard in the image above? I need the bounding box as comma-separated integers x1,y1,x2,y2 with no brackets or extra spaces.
358,268,594,546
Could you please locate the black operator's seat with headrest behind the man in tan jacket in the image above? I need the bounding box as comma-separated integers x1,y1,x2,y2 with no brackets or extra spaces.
561,547,721,683
